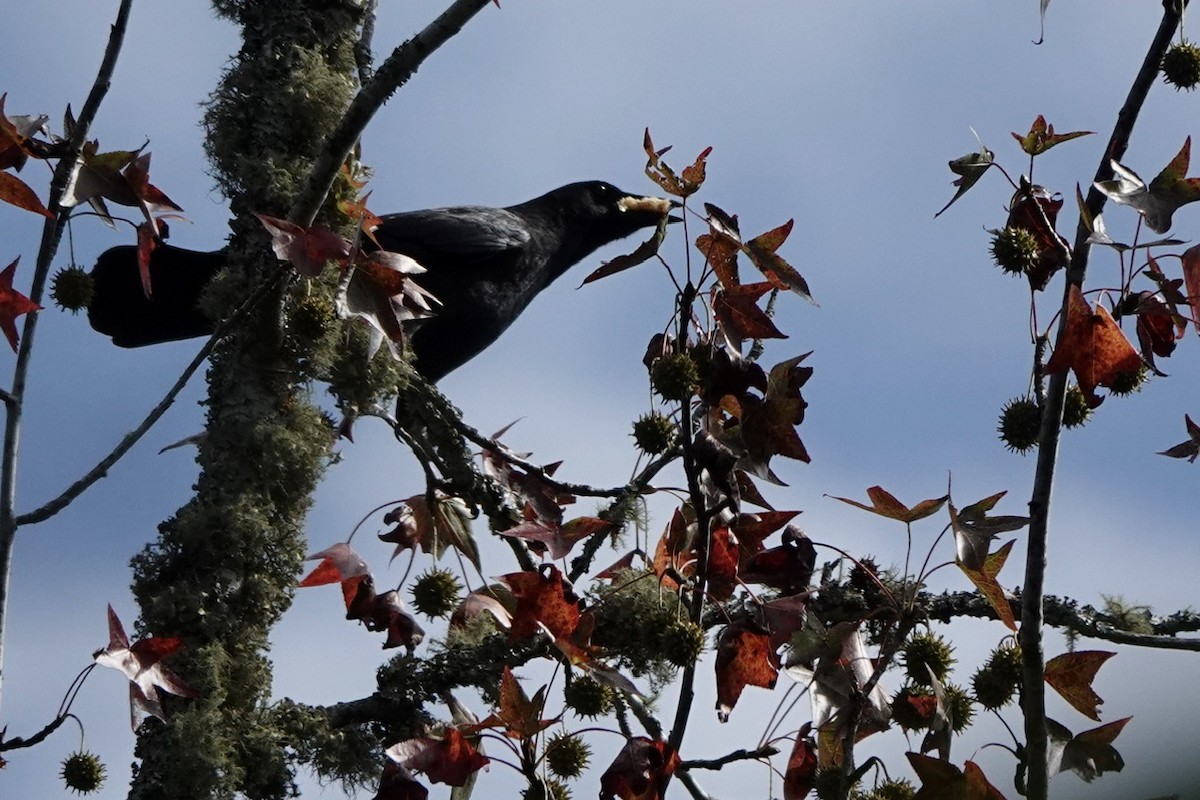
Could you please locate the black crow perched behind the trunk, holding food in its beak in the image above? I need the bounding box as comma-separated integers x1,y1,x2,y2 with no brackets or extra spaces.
88,181,676,380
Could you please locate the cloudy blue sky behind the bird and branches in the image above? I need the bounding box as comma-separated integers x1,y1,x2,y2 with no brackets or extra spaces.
0,0,1200,800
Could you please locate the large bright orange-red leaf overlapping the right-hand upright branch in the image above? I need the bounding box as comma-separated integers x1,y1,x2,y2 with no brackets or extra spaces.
1045,285,1141,408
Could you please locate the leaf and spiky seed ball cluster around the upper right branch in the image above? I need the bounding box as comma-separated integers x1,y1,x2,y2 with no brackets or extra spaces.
938,115,1200,457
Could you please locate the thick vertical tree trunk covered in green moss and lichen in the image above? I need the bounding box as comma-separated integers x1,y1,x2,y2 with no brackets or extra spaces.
131,0,362,800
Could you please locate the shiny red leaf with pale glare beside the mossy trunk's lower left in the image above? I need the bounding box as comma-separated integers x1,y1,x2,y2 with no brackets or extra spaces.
92,606,199,730
